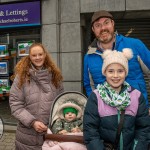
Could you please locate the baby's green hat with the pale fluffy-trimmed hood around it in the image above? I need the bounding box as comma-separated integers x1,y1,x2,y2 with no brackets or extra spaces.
57,99,82,119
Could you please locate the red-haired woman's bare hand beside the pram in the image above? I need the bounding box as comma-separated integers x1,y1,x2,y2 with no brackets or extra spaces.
32,121,47,133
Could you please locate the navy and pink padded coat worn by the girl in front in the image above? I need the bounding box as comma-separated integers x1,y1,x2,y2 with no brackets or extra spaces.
83,86,150,150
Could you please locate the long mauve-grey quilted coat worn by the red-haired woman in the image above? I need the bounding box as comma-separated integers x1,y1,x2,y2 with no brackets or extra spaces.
9,69,63,150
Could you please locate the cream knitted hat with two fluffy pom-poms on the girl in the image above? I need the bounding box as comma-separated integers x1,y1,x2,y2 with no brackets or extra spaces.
102,48,133,76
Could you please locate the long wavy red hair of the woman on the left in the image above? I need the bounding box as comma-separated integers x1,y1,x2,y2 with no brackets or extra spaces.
12,43,63,88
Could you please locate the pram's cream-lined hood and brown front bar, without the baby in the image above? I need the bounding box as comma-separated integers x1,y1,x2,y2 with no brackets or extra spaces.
44,91,87,144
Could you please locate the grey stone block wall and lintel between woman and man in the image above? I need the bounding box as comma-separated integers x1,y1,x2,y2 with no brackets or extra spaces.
0,0,150,92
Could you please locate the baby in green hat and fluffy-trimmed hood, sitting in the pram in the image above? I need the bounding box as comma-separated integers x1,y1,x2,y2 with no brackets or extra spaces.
52,100,83,134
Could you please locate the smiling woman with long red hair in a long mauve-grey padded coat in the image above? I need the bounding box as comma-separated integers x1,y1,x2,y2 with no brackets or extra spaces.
9,43,63,150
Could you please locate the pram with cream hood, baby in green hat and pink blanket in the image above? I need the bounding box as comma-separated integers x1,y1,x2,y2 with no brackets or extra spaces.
42,92,87,150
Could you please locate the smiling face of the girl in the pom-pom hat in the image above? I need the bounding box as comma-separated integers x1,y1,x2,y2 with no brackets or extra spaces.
105,63,126,92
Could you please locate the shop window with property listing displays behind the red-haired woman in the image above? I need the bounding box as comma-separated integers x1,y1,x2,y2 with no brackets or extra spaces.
0,28,41,99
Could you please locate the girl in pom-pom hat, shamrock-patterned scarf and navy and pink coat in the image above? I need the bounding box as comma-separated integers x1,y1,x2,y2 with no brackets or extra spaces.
83,49,150,150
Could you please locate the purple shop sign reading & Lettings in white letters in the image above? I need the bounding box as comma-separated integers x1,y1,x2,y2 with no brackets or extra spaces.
0,0,41,28
